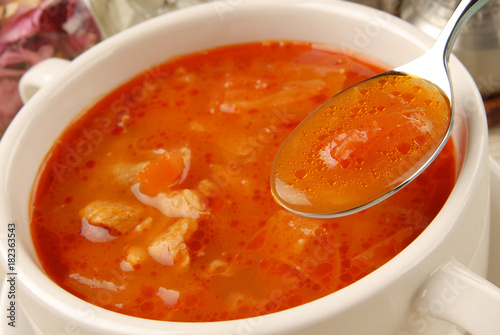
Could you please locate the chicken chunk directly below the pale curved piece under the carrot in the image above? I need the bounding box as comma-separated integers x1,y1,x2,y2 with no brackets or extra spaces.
148,218,198,267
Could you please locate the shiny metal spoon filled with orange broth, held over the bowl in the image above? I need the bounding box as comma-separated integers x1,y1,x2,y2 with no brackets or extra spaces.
271,0,488,218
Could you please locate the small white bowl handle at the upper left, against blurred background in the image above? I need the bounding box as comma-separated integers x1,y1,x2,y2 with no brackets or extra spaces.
19,58,70,103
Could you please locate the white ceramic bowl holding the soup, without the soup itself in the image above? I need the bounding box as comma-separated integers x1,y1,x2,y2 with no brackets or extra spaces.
0,0,500,335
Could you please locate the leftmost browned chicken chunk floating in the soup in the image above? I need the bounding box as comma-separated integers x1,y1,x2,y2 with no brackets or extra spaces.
80,201,143,236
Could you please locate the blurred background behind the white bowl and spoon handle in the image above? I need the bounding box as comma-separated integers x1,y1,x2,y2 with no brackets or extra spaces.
0,0,500,138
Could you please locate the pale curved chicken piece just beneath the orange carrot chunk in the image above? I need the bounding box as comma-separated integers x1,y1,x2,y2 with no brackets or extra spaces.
131,183,207,219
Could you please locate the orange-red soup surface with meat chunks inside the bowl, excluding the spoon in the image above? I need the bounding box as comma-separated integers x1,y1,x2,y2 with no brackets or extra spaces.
31,42,455,321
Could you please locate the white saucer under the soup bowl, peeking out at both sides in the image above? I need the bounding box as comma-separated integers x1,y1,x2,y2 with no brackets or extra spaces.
0,157,500,335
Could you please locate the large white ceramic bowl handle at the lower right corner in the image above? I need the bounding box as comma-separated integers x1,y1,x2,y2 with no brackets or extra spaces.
416,260,500,335
